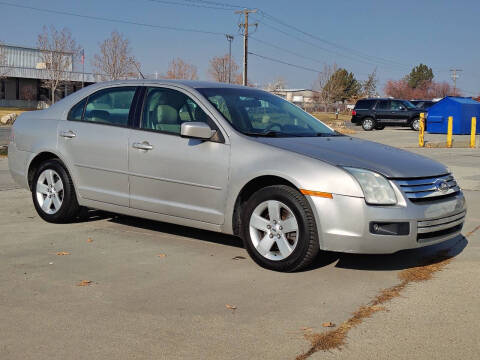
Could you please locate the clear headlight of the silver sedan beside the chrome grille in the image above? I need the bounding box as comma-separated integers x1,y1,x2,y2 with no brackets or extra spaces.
344,167,397,205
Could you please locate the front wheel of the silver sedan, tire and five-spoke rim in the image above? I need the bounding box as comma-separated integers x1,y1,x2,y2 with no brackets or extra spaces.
241,185,320,272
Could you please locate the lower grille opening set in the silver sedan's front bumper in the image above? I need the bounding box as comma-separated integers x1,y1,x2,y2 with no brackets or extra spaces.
417,210,466,242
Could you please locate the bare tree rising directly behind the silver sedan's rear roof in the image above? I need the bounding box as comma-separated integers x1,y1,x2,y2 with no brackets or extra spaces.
92,31,140,80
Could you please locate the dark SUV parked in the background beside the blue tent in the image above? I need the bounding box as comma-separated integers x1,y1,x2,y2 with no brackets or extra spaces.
352,99,424,131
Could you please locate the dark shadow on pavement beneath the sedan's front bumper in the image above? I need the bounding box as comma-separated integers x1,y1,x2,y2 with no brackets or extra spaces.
335,235,468,271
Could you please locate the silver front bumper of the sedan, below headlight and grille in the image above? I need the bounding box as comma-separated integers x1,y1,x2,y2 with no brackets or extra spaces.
309,192,467,254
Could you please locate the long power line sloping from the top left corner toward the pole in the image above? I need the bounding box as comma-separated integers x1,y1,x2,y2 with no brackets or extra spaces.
0,1,225,36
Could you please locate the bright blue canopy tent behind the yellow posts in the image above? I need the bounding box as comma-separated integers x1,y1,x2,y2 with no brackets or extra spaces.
426,96,480,135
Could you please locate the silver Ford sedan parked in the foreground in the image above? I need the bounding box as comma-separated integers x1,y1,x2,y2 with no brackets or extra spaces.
8,80,466,271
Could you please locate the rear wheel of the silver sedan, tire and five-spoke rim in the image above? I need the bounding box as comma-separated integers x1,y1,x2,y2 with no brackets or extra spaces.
32,159,80,223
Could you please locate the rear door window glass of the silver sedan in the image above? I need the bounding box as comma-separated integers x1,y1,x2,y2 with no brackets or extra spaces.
81,86,136,126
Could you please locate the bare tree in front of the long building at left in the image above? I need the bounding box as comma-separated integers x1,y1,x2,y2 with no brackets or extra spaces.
37,25,79,104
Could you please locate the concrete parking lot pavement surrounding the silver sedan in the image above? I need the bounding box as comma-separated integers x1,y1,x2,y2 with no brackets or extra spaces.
0,129,480,359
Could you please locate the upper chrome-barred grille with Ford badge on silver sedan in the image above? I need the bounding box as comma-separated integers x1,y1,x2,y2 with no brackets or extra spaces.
394,174,460,203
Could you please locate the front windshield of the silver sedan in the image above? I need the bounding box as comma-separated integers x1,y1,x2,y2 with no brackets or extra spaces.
197,88,340,137
